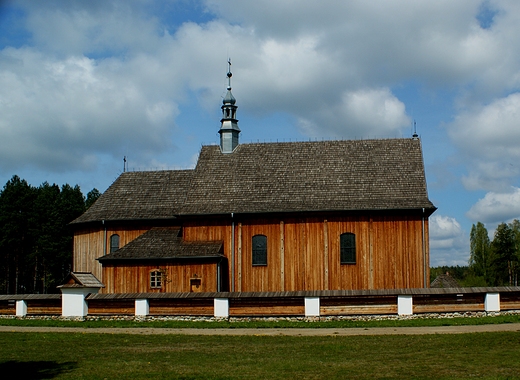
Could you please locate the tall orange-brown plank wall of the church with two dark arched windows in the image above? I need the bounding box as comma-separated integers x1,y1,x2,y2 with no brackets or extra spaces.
183,214,429,292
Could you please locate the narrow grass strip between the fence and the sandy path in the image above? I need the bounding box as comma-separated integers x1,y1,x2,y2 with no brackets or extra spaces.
0,314,520,329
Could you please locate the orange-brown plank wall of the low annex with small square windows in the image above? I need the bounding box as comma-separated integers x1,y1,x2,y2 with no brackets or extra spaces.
102,263,217,293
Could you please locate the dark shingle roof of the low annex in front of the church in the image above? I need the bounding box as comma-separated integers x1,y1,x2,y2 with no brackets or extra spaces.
98,227,223,263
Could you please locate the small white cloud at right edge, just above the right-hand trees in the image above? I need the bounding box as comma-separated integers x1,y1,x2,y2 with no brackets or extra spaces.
467,187,520,224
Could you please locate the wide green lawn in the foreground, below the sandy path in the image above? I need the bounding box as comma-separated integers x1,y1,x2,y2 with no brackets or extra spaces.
0,332,520,379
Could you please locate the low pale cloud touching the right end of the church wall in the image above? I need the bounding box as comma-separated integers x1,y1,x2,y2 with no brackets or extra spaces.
429,214,469,267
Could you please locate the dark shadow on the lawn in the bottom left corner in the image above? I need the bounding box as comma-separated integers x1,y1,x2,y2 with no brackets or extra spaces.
0,360,77,379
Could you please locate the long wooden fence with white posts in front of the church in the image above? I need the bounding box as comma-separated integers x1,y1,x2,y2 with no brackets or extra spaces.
0,287,520,318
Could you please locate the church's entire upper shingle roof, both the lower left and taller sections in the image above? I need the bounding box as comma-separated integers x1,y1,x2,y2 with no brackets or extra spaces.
73,138,435,223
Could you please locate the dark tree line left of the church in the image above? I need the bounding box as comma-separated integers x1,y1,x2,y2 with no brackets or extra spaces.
0,175,101,294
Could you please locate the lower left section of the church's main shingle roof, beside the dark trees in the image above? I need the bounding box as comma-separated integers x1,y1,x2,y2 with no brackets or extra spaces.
72,170,193,223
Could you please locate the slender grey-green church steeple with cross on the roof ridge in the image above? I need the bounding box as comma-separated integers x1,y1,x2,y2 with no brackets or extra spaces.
218,59,240,153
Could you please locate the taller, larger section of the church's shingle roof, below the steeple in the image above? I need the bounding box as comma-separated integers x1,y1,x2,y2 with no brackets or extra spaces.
182,139,435,214
